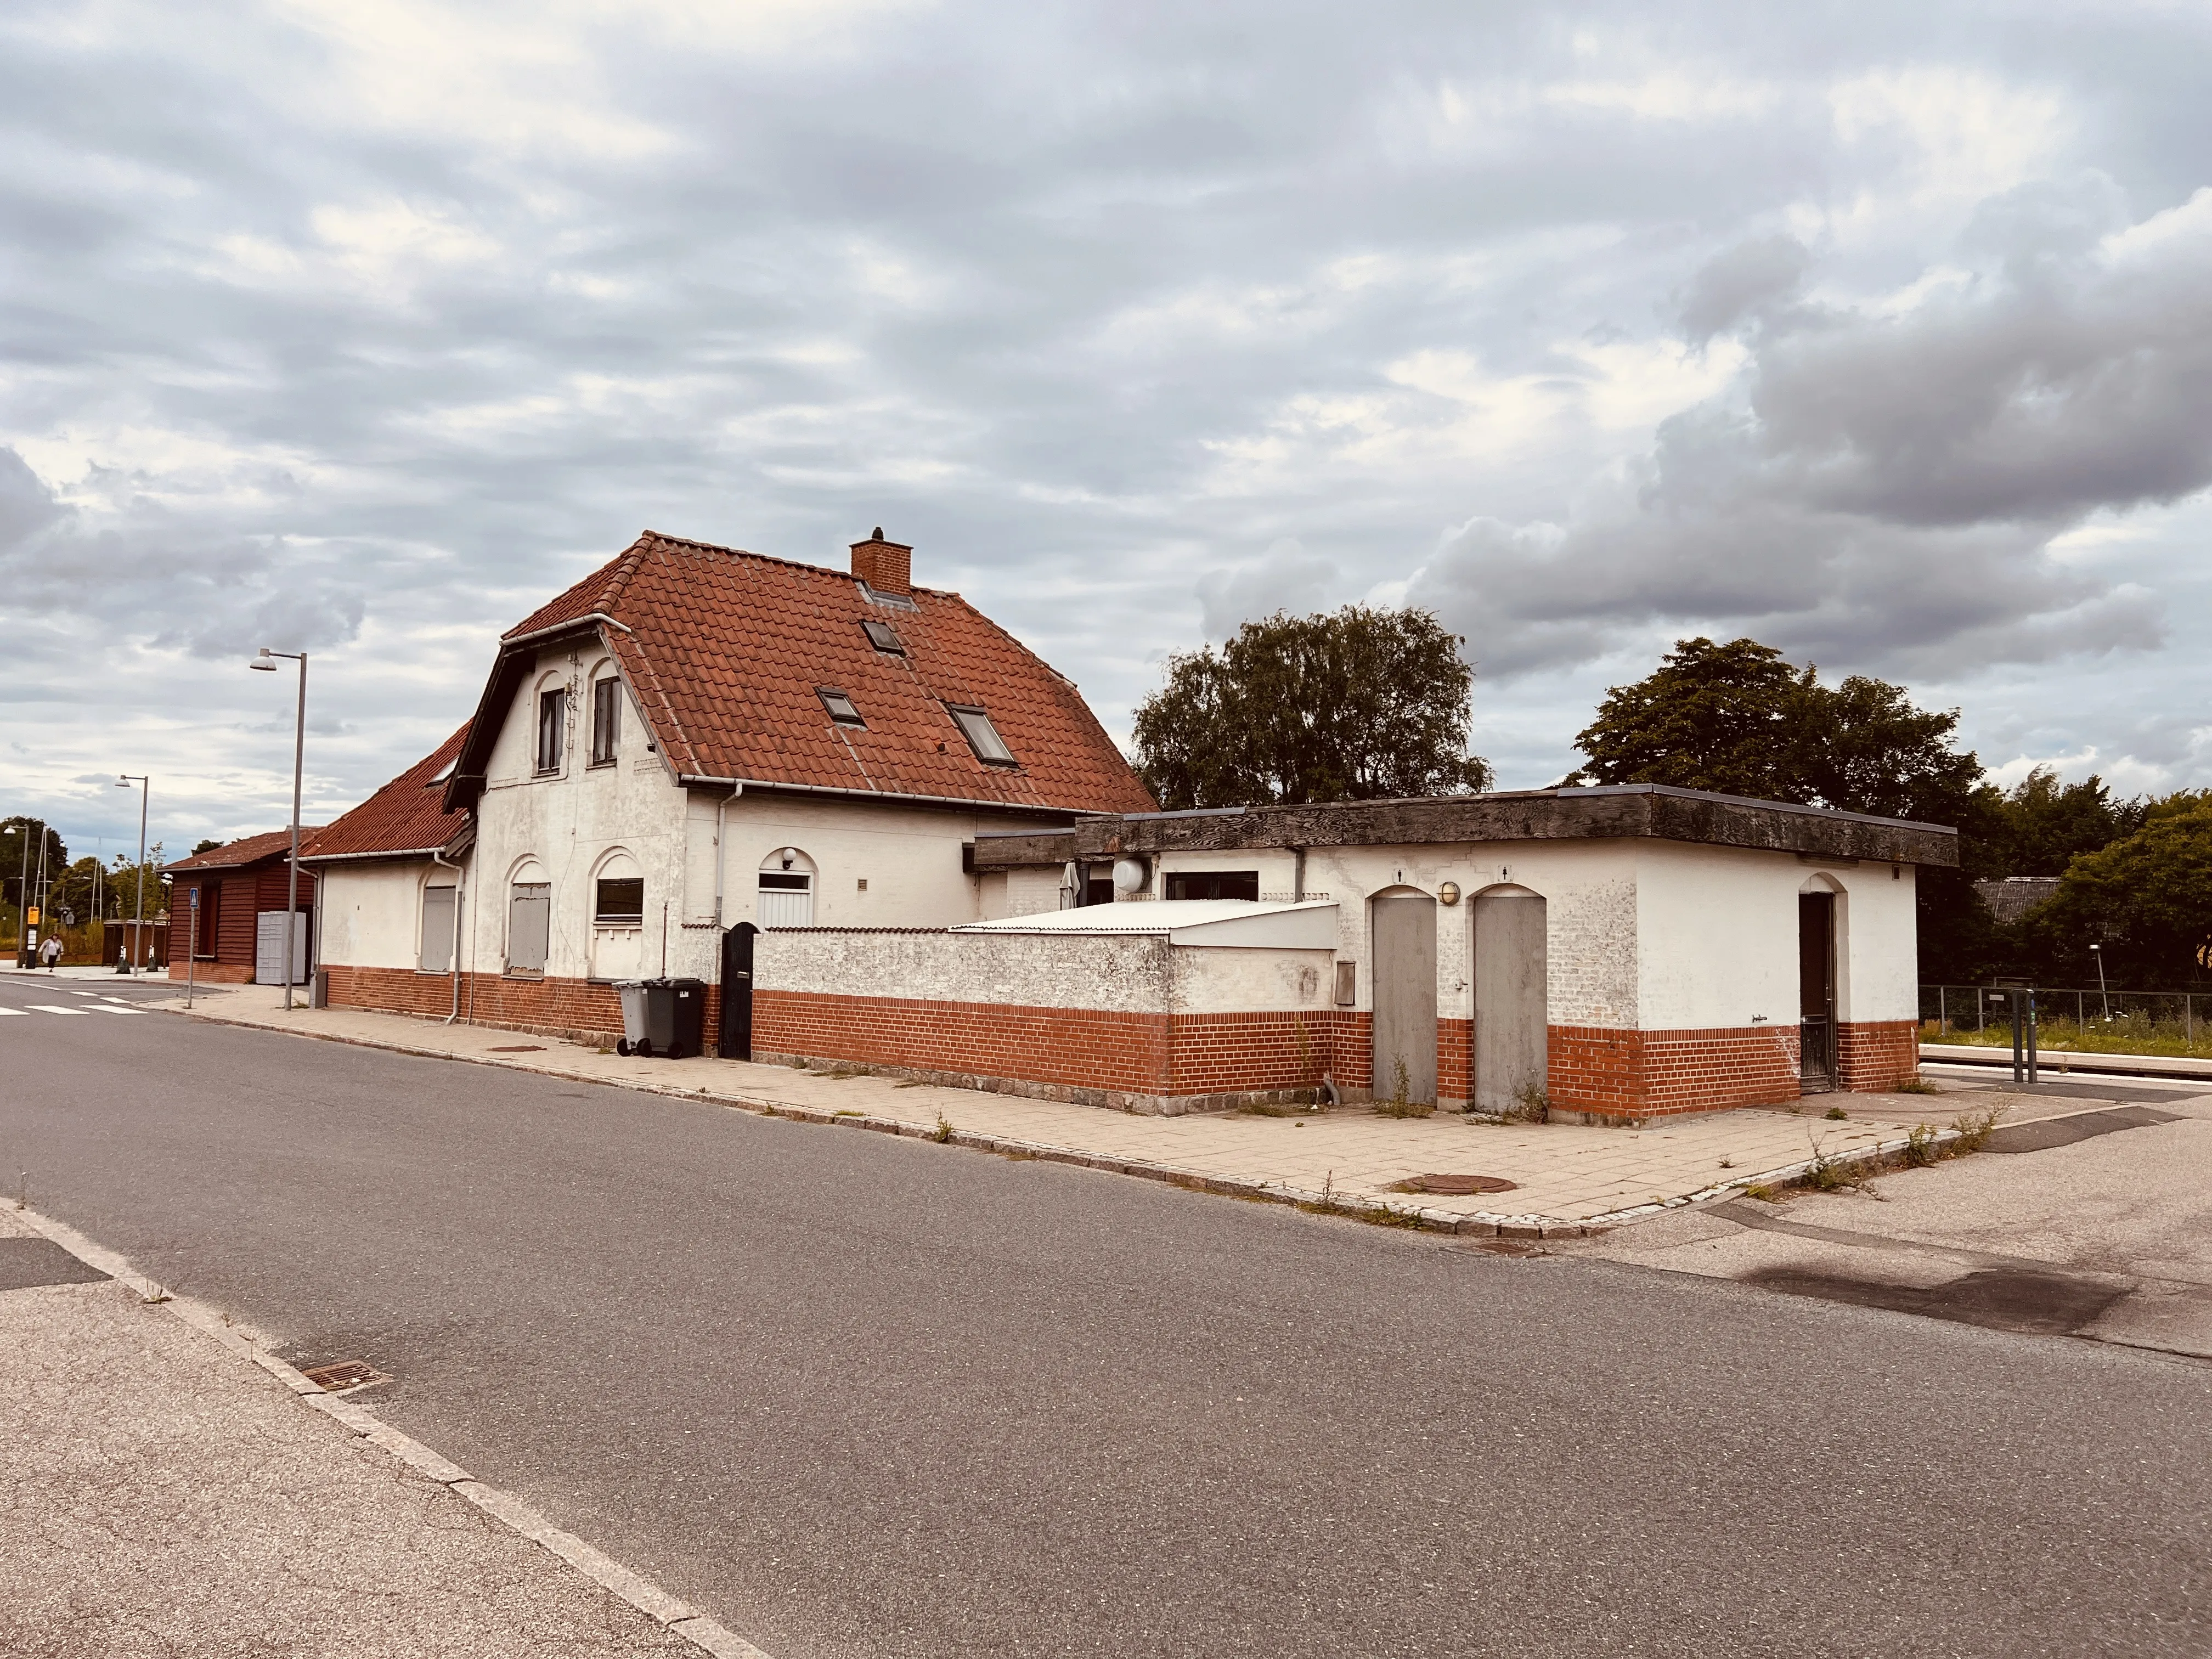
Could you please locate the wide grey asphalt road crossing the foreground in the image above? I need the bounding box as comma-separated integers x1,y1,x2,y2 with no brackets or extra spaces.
0,995,2212,1659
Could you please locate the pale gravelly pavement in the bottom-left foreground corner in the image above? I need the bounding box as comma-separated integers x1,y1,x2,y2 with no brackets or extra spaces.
0,1207,761,1659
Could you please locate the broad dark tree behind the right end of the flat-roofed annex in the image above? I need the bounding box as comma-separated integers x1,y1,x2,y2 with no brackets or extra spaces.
1575,639,2004,978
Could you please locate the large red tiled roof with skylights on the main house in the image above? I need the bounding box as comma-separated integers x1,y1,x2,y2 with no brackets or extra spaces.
482,531,1155,812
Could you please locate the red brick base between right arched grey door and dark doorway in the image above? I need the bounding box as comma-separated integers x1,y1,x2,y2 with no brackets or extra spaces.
1546,1026,1798,1117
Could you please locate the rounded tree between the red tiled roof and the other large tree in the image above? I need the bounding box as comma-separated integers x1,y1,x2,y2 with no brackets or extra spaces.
1135,604,1491,812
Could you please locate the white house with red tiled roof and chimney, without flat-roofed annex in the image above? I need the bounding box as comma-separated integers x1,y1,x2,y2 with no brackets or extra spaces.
303,531,1153,1033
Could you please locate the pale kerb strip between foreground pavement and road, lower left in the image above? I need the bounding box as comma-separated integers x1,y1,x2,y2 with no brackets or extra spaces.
7,1203,770,1659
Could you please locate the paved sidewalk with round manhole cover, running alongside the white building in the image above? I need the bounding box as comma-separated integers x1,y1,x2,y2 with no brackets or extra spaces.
148,986,2081,1239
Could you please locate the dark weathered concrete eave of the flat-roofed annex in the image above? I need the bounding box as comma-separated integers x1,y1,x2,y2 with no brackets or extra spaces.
975,783,1957,870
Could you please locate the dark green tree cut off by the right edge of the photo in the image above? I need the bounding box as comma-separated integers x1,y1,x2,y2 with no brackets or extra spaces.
2024,789,2212,991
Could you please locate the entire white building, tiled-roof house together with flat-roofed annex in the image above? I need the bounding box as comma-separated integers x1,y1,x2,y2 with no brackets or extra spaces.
307,531,1957,1121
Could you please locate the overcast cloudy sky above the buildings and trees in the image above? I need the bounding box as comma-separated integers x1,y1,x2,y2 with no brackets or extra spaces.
0,0,2212,851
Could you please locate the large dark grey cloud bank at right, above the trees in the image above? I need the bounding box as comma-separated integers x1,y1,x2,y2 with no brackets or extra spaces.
1413,193,2212,690
